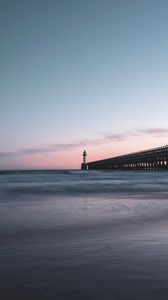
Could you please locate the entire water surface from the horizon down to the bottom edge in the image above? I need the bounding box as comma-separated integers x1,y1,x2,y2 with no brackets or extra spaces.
0,170,168,300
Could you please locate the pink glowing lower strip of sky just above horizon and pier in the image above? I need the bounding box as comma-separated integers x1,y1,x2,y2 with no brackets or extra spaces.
1,128,168,169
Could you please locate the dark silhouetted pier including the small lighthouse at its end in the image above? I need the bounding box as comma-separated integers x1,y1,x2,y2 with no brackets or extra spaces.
81,145,168,170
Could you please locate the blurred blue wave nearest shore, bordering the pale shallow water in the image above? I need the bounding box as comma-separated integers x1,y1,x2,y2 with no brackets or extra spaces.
1,184,168,198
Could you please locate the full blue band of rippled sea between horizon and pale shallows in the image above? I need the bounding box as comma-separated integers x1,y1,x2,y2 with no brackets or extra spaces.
0,170,168,198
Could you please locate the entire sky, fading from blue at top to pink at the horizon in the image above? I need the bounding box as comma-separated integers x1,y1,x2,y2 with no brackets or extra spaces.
0,0,168,170
